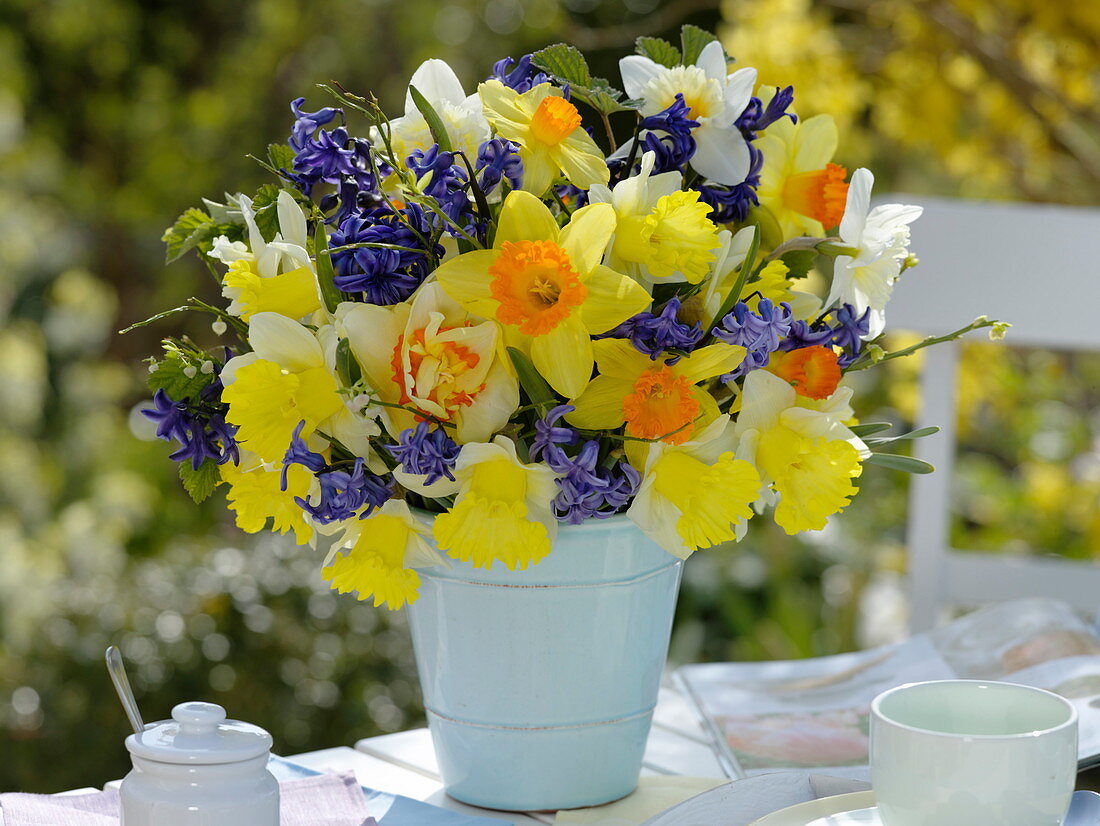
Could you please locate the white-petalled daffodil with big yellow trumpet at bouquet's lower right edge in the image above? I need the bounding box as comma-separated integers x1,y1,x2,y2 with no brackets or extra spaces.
734,370,868,535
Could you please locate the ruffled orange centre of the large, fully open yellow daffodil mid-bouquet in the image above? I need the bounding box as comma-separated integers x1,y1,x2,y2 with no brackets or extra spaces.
488,240,589,335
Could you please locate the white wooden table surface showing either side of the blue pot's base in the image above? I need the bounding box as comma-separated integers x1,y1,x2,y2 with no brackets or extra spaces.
287,687,726,826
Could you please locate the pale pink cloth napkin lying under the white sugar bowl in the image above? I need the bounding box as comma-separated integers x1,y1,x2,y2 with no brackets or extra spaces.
0,772,377,826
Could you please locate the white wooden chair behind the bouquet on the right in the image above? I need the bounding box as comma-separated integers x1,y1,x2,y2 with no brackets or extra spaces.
878,196,1100,631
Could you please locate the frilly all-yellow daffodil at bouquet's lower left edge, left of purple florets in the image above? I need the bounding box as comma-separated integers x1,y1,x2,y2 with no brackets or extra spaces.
219,451,314,544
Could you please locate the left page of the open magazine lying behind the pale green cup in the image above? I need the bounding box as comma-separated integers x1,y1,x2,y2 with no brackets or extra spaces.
678,637,955,780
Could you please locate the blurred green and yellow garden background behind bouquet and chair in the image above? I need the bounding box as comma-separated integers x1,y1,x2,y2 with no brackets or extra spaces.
0,0,1100,792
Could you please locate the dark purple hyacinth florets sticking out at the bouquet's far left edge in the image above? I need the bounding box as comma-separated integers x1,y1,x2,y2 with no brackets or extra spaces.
142,381,241,471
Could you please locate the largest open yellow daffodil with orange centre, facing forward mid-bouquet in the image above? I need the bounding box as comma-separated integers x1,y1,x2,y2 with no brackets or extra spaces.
436,190,651,398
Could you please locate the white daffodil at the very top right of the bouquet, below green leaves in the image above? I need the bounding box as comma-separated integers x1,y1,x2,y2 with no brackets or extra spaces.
619,41,757,186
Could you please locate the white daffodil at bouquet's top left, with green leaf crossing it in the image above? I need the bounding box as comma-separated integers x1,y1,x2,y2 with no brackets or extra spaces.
389,58,490,164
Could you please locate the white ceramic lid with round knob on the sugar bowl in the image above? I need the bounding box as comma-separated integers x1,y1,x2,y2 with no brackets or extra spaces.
127,703,272,764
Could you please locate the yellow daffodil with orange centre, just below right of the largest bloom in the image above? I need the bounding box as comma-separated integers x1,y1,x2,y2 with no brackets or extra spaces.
565,339,745,459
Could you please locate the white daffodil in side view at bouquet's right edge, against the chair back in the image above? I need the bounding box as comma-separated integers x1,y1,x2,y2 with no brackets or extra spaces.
825,169,924,339
